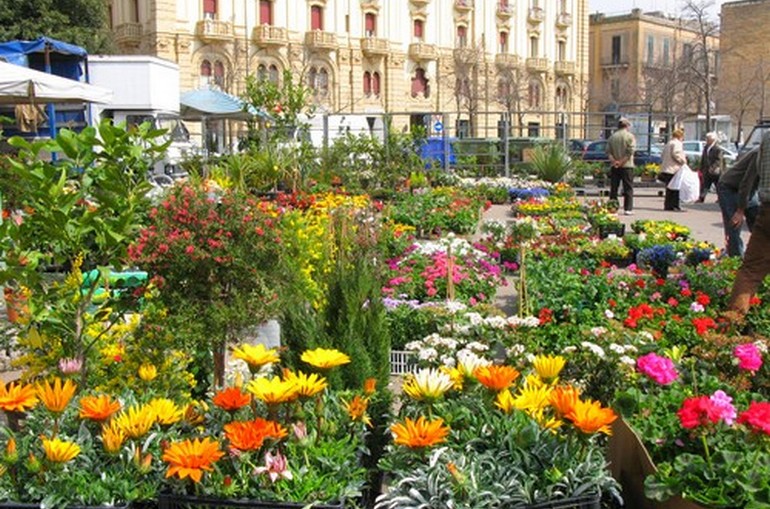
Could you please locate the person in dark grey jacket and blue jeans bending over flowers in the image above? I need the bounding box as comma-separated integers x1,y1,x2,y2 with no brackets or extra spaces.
717,148,759,258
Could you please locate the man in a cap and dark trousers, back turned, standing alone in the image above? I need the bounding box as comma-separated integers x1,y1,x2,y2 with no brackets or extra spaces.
607,117,636,216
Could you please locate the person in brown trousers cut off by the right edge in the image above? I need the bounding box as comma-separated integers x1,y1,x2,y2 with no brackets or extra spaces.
727,132,770,317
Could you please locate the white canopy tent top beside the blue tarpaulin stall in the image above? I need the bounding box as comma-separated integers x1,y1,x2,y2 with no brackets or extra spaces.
0,62,112,104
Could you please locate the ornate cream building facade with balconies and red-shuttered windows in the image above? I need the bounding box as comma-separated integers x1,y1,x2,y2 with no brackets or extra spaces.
109,0,588,135
